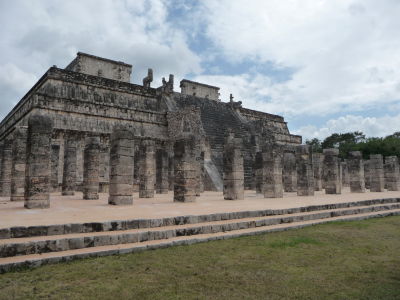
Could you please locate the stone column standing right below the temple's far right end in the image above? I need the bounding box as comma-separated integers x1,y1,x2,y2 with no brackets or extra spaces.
296,145,314,196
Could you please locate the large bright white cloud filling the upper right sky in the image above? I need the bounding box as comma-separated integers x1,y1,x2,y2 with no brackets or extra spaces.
203,0,400,116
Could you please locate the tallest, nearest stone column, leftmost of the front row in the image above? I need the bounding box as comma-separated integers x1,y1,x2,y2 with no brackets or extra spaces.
24,114,53,208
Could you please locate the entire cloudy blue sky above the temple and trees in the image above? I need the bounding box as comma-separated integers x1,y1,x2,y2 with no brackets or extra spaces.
0,0,400,139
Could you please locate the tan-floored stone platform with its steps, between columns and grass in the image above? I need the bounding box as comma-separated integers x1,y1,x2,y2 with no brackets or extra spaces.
0,189,400,273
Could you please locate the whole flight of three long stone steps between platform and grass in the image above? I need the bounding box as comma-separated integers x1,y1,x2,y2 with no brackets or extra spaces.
0,198,400,273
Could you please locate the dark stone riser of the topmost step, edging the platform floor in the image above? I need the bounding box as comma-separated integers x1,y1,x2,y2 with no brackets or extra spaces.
0,198,400,242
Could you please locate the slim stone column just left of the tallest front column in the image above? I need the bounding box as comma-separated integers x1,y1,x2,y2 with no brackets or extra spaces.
11,126,28,201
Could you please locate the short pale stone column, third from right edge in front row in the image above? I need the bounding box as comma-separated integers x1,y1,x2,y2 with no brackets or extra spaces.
347,151,365,193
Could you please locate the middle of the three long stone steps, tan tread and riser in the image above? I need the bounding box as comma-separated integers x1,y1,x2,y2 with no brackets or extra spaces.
0,203,400,258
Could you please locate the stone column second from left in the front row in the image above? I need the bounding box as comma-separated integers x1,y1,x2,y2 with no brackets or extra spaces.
108,126,135,205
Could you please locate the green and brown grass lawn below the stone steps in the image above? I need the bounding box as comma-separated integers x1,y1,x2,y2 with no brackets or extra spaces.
0,217,400,300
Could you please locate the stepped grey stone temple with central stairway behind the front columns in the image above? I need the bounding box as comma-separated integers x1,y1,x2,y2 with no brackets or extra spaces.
0,52,301,200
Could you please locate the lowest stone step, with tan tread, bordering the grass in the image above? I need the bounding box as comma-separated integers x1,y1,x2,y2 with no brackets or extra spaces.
0,209,400,273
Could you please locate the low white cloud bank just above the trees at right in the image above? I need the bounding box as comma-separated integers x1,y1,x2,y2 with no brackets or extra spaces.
294,114,400,140
